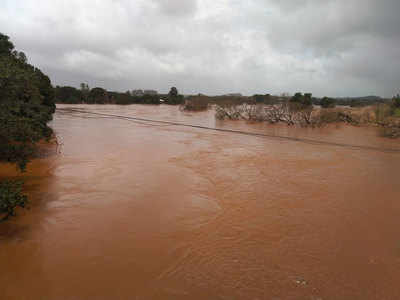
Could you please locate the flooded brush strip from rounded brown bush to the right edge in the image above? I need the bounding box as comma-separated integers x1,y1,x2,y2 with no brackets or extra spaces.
176,93,400,138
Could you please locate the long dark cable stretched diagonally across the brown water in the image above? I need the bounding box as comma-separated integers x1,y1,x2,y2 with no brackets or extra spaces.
57,108,400,153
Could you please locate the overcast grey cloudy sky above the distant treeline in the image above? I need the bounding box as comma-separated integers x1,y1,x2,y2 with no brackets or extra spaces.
0,0,400,97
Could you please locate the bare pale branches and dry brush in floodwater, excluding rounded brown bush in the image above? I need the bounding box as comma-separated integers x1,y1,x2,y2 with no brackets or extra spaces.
211,93,400,138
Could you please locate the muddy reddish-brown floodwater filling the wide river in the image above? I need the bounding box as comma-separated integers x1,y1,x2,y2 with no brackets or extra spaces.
0,105,400,300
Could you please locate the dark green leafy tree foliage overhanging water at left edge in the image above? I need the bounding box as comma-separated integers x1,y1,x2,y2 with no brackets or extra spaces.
0,33,55,220
